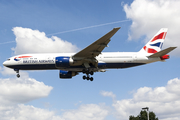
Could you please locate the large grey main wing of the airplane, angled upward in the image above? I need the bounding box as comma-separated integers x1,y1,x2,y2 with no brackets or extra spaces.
73,27,120,59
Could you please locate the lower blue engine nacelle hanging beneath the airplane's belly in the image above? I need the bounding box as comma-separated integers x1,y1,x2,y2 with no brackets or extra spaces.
59,70,77,79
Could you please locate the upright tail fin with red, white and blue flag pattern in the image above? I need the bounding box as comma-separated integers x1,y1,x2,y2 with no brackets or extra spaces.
139,28,168,56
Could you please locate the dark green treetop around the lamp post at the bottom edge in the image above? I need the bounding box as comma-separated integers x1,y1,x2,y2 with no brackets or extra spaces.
129,110,159,120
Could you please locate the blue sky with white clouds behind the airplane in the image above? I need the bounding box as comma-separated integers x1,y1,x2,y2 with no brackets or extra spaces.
0,0,180,120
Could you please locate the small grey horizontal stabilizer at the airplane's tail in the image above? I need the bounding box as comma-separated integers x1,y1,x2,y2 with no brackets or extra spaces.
149,47,177,58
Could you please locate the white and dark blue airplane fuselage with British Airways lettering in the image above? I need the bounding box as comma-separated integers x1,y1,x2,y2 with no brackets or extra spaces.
3,52,161,71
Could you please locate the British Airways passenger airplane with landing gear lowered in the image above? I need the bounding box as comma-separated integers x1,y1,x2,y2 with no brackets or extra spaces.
3,27,176,81
